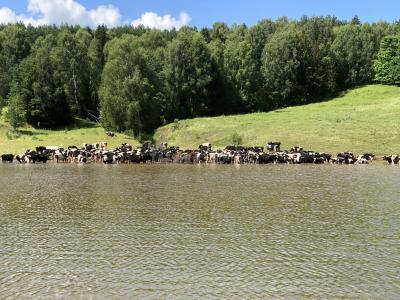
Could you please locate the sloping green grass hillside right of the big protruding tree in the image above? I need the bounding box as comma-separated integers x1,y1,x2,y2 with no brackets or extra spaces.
155,85,400,155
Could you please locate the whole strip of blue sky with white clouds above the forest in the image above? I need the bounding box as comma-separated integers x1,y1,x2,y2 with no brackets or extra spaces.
0,0,400,29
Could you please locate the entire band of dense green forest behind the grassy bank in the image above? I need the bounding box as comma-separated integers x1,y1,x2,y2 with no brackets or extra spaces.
0,16,400,137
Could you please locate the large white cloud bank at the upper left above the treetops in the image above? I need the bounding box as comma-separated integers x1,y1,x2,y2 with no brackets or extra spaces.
0,0,122,27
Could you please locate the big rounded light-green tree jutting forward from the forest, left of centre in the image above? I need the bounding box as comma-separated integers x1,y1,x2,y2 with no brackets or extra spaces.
100,35,162,137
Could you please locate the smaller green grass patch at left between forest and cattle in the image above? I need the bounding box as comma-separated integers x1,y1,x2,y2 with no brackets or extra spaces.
0,120,138,154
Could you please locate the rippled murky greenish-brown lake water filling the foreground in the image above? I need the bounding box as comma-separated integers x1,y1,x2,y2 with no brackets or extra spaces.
0,164,400,299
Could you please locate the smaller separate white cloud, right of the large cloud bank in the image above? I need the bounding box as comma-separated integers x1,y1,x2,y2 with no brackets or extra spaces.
131,12,191,30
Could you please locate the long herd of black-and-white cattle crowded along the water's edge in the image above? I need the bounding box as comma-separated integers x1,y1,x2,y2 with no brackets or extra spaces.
1,142,400,165
